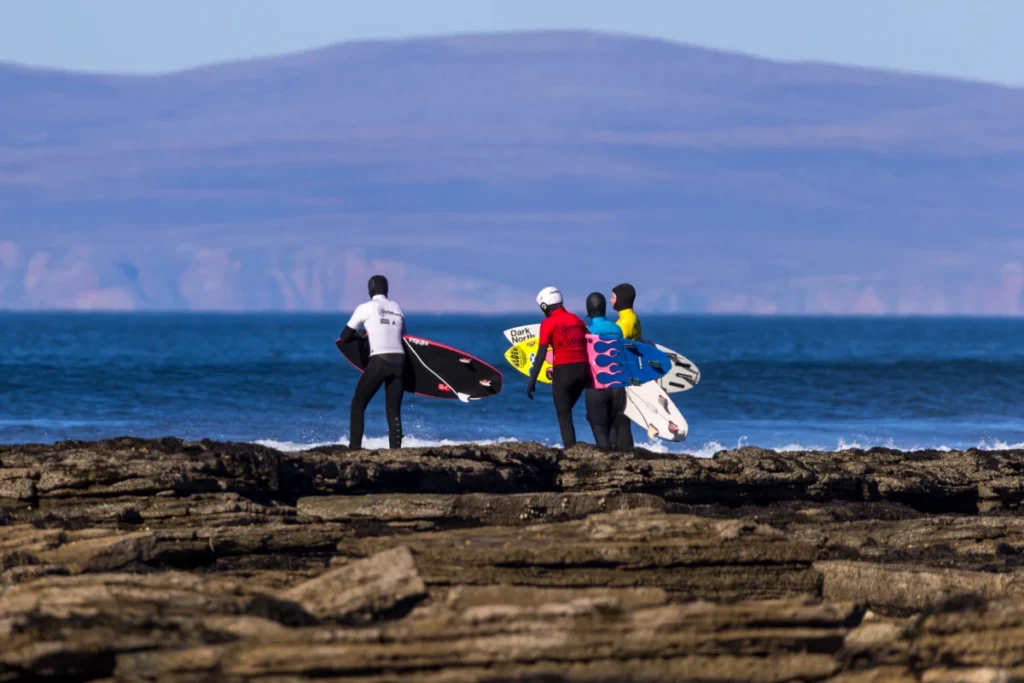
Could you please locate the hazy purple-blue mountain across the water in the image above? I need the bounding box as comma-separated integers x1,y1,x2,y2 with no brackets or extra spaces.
0,33,1024,314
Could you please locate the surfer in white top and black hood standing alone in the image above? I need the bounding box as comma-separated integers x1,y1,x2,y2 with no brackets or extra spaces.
339,275,406,449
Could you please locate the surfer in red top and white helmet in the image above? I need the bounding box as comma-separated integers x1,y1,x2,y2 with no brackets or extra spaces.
526,287,590,449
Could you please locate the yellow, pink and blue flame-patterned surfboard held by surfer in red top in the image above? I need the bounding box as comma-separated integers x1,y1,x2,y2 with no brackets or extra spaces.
505,335,672,389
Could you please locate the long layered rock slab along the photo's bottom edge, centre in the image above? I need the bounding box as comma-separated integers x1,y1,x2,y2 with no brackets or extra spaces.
116,599,856,681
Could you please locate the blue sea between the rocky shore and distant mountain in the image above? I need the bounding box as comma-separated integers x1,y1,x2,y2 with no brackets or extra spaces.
0,312,1024,456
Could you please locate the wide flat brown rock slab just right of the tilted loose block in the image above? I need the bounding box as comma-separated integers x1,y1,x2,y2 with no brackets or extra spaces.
348,510,818,599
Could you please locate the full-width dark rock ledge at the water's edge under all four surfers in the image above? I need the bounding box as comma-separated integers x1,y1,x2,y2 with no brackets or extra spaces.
6,438,1024,516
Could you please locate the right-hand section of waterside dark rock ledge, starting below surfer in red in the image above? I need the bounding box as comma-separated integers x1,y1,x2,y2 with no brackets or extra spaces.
559,447,1024,513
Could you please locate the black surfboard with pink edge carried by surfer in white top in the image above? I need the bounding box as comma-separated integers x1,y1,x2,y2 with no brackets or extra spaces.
335,335,504,401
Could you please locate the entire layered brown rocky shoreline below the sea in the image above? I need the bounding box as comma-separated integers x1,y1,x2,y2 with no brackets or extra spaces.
0,438,1024,681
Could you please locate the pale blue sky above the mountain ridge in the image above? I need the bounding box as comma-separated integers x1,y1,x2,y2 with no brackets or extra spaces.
0,0,1024,85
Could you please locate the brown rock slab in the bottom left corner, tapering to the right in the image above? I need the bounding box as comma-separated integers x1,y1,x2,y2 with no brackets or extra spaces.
0,571,315,680
